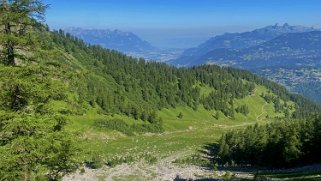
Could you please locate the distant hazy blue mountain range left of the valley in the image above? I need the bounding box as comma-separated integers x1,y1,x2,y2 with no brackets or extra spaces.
65,28,156,53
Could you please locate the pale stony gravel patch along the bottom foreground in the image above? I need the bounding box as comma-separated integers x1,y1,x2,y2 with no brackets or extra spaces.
63,152,213,181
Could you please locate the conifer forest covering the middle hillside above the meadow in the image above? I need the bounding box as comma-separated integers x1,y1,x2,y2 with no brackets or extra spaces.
51,30,320,122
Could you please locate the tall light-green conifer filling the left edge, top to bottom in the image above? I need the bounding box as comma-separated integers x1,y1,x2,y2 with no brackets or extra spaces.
0,0,78,180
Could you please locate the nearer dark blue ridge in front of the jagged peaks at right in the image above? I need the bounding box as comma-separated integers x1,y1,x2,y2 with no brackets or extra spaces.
196,31,321,69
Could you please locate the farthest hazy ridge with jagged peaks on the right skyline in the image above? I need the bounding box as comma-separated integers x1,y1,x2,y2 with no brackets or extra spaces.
171,23,316,66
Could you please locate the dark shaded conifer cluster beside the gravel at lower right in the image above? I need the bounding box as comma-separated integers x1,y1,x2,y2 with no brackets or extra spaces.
213,117,321,167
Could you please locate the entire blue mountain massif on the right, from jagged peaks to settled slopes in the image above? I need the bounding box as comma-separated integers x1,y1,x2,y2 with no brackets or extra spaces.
171,24,321,103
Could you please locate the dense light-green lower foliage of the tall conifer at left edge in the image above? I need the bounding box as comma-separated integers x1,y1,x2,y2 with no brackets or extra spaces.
0,65,78,180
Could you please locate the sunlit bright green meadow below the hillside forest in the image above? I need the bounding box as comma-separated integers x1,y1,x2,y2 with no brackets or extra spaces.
63,86,282,162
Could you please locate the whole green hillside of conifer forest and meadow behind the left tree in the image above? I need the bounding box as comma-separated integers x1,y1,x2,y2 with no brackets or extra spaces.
2,28,319,167
